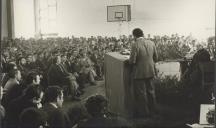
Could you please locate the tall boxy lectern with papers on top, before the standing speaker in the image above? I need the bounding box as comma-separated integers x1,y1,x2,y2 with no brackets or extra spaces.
105,52,133,118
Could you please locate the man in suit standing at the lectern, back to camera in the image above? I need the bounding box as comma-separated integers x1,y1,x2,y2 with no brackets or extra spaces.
129,28,157,118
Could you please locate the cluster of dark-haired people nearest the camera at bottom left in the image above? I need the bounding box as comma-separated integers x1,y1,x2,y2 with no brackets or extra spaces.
0,79,132,128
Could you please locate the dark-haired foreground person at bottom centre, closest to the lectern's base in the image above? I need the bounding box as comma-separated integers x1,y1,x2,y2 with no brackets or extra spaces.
78,95,131,128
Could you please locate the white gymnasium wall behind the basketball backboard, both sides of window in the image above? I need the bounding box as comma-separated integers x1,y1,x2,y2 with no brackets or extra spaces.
14,0,215,39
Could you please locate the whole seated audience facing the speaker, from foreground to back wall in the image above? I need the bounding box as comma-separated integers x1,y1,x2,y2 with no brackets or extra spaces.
0,33,209,128
